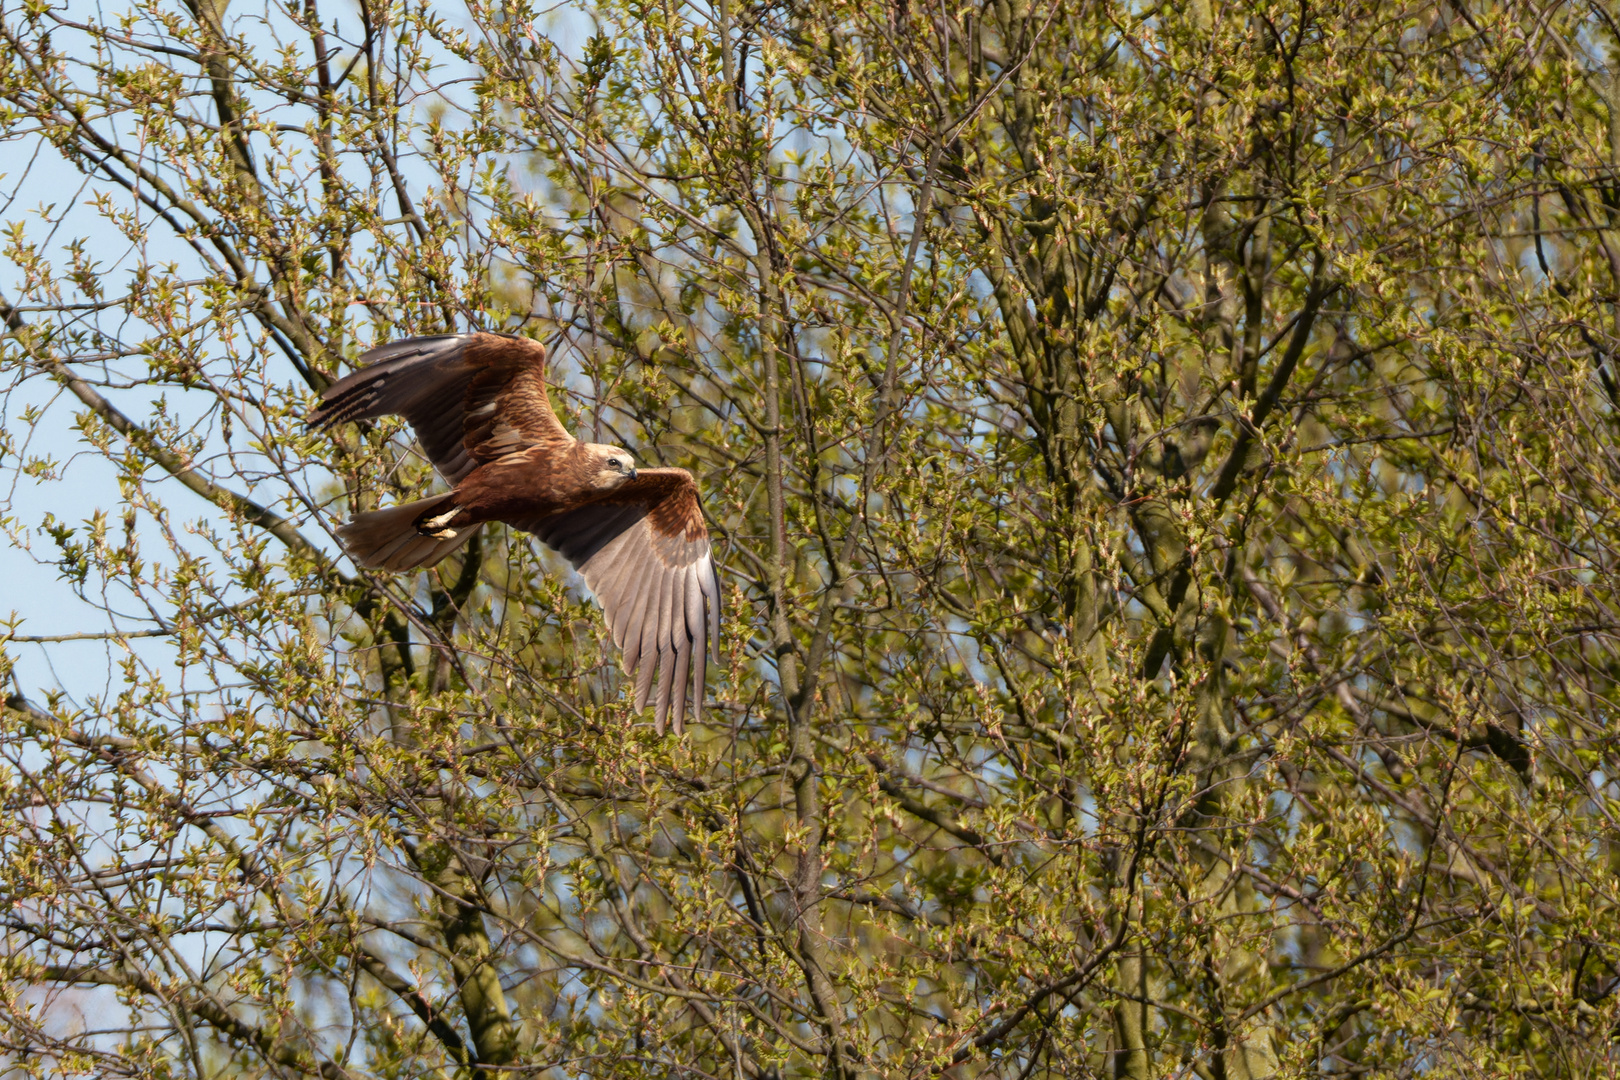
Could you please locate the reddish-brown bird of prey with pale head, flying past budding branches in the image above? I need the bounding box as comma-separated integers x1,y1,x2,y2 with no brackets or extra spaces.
309,334,719,733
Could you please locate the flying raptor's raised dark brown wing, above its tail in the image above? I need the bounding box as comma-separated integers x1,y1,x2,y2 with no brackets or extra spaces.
309,332,573,484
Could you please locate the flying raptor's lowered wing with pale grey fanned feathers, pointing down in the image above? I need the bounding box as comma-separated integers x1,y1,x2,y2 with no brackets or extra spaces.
509,468,719,733
